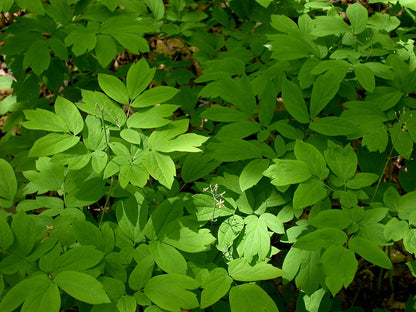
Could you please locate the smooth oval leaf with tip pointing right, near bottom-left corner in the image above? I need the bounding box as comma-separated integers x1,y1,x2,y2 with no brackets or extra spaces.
54,271,110,304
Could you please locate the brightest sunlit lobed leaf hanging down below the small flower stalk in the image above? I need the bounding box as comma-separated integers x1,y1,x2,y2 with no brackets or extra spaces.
243,215,270,262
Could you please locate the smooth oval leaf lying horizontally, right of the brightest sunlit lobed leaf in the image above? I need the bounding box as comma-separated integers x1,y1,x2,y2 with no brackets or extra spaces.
293,228,347,251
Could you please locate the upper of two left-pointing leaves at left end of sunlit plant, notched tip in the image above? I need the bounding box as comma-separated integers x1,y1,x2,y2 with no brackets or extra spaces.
22,108,68,132
